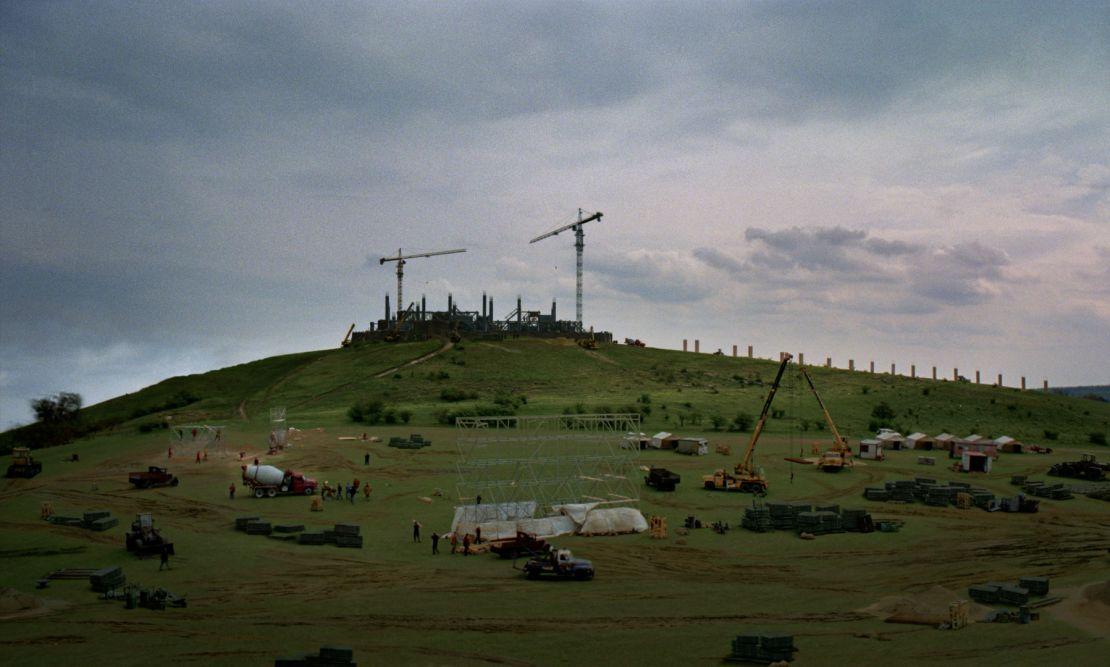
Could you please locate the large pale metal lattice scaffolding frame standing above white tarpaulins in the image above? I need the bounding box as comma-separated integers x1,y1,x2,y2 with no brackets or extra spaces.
455,413,640,514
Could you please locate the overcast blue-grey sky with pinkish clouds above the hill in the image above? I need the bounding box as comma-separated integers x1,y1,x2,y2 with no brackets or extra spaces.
0,0,1110,428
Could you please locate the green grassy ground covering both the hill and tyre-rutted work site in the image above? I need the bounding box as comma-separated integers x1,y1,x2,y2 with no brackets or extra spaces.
0,341,1110,666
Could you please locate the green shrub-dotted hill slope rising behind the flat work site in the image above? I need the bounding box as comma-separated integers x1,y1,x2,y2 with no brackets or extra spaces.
0,338,1110,451
